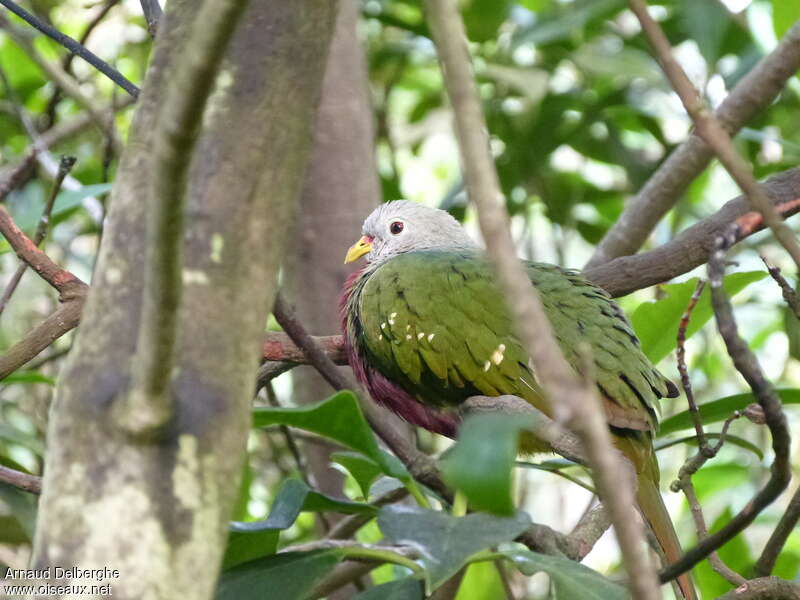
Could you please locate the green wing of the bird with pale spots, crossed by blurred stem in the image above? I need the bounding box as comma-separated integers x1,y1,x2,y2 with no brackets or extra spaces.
359,250,671,429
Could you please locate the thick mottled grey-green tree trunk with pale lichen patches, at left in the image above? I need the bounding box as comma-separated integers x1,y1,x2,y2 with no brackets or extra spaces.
34,0,336,600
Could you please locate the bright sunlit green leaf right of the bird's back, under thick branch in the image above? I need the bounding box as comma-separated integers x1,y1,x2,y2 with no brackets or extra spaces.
631,271,767,363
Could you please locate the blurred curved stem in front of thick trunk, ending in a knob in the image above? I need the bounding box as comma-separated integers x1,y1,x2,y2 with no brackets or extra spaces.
122,0,247,434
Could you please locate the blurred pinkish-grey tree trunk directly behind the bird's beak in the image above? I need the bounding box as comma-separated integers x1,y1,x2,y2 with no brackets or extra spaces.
286,0,380,495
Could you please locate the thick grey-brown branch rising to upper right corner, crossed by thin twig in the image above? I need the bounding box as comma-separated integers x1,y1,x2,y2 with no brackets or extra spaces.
586,23,800,270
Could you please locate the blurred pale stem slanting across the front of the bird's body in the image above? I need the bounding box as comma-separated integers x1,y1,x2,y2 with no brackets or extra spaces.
425,0,660,600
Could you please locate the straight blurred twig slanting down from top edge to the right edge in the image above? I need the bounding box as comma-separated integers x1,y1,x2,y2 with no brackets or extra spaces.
630,0,800,272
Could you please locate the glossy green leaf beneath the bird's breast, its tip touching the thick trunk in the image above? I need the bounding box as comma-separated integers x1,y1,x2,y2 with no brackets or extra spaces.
253,390,410,481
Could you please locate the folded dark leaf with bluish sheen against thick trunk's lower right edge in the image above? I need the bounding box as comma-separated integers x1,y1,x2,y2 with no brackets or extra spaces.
222,479,377,569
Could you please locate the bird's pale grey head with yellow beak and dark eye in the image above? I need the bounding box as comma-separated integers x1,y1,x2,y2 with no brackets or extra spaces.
345,200,477,263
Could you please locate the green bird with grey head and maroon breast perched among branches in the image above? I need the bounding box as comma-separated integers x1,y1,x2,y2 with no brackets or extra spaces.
340,200,696,599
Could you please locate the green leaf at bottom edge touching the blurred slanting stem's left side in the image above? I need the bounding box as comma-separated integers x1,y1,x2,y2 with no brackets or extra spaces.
503,550,630,600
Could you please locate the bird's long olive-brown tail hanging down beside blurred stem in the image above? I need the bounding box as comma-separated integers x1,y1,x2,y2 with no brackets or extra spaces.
616,434,697,600
